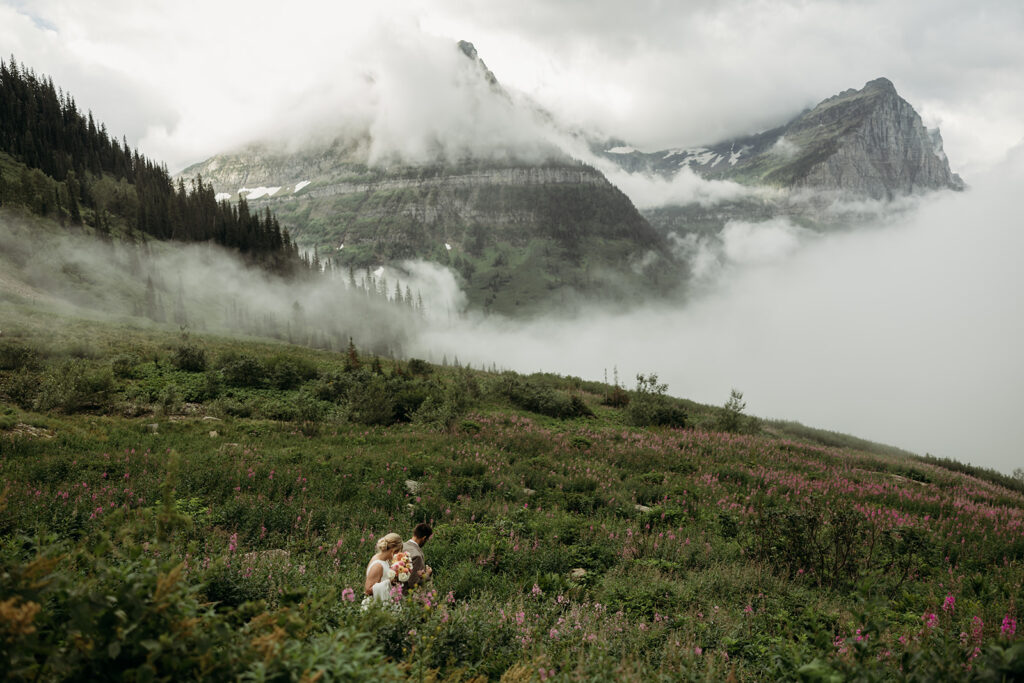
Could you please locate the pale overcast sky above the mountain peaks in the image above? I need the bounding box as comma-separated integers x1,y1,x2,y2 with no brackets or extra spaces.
6,0,1024,177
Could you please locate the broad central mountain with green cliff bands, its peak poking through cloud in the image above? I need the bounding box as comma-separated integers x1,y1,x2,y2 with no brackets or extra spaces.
181,42,670,313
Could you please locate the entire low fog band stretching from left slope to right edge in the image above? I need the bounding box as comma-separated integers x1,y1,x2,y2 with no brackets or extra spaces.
0,147,1024,472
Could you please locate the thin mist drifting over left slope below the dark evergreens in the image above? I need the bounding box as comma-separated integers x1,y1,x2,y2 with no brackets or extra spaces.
0,212,468,356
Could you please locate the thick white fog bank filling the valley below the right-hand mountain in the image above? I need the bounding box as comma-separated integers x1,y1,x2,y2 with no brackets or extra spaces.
413,146,1024,472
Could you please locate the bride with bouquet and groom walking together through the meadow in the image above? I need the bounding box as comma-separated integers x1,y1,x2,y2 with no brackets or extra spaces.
362,522,433,608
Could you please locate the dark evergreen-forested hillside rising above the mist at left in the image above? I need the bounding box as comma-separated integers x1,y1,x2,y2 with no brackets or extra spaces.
0,57,308,274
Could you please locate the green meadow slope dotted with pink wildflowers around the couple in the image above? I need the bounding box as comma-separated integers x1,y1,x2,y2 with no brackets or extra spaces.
0,304,1024,680
